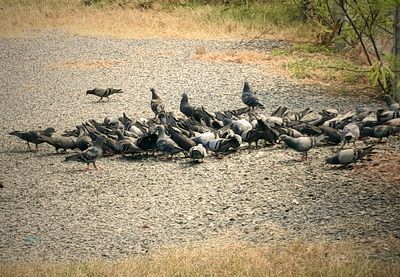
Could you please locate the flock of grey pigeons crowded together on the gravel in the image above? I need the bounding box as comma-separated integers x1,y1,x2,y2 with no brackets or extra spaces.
10,82,400,169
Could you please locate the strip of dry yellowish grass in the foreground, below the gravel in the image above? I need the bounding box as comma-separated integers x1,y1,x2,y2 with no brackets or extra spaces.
0,239,400,277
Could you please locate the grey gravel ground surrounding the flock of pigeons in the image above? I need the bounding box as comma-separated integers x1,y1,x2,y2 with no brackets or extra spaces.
0,32,400,261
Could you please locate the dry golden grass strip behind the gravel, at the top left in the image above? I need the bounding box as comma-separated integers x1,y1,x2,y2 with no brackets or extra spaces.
0,0,306,39
